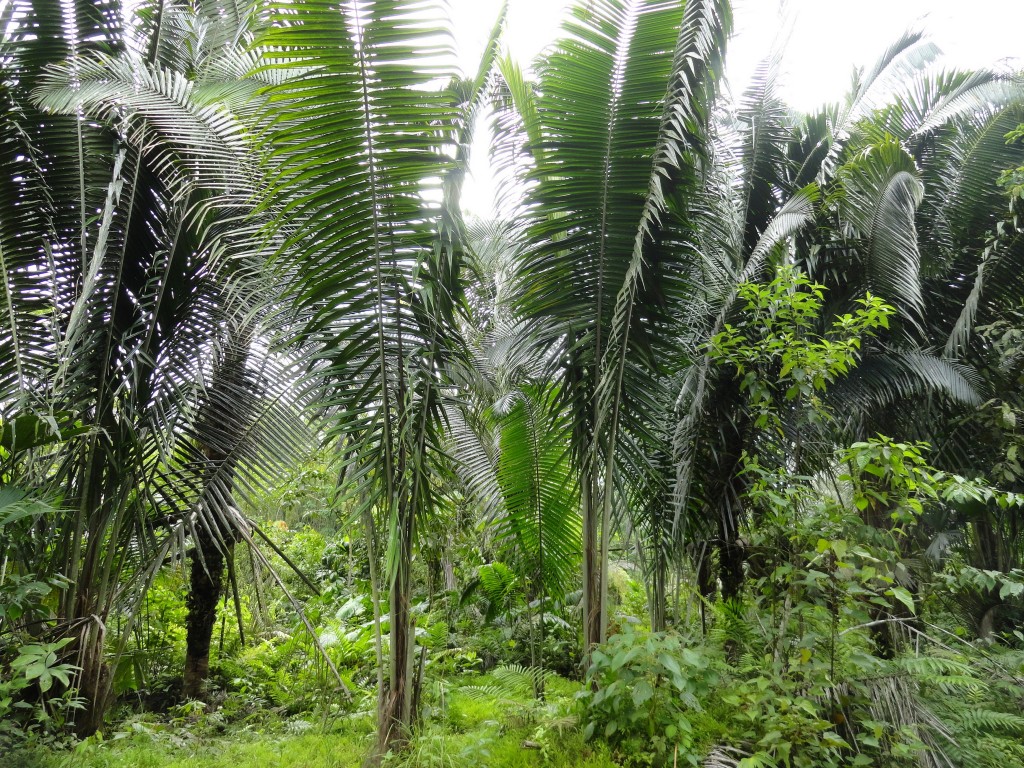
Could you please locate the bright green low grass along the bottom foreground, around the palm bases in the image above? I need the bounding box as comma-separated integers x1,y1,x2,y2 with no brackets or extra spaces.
19,677,614,768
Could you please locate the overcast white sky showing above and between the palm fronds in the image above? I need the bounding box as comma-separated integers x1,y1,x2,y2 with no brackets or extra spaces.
449,0,1024,213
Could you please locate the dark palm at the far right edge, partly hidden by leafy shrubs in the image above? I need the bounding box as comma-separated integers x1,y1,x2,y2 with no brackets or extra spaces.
860,72,1024,635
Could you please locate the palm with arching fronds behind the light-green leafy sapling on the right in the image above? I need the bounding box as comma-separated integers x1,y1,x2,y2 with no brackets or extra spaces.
651,33,1008,618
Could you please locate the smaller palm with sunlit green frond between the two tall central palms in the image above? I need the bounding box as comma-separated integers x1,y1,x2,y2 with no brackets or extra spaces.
450,222,581,684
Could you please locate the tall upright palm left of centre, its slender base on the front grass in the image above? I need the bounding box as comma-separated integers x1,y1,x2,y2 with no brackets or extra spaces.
253,0,505,755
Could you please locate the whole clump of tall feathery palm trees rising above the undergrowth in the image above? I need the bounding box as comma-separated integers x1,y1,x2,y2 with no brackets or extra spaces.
0,0,1024,752
